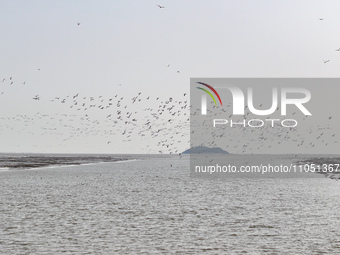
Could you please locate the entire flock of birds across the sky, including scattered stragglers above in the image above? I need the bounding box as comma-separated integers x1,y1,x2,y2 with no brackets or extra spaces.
0,13,340,158
